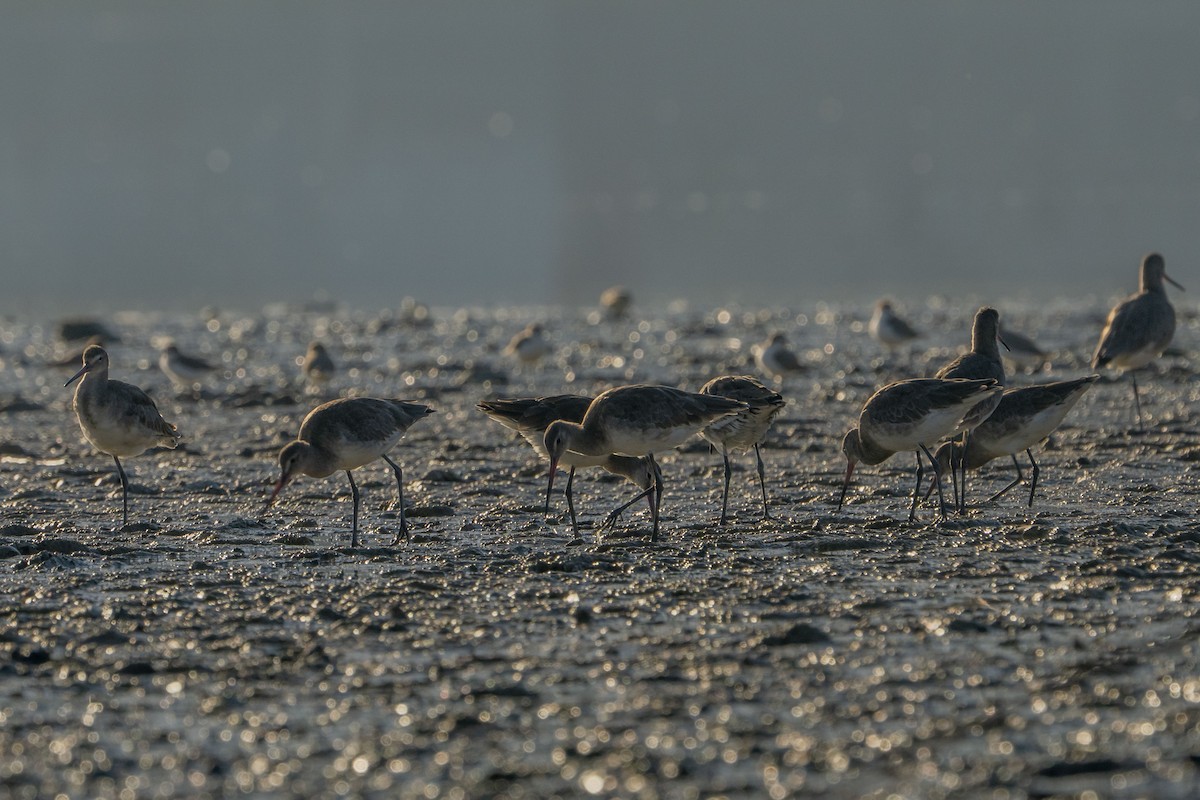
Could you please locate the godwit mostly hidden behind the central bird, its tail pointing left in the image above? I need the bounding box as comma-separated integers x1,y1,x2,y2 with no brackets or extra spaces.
475,395,654,536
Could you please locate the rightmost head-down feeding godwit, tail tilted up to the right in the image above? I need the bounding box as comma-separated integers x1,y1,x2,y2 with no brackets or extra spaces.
926,375,1100,509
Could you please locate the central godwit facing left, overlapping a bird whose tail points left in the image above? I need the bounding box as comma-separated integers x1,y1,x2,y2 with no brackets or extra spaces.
545,385,746,541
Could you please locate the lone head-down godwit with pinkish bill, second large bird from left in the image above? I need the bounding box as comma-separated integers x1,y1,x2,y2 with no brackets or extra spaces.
264,397,433,547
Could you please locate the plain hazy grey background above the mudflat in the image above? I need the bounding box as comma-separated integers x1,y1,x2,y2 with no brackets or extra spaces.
0,0,1200,311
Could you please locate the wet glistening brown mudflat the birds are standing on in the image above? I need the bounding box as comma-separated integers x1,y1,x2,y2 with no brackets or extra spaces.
0,301,1200,798
